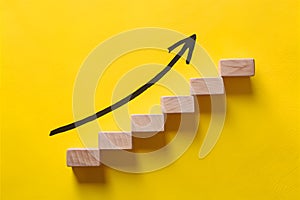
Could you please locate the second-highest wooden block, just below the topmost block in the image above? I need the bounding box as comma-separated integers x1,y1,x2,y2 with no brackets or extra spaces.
190,77,224,95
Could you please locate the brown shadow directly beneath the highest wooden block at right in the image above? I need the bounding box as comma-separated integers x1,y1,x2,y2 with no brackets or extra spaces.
223,77,253,95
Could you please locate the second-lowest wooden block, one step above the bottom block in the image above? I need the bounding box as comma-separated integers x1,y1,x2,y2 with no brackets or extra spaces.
98,131,132,149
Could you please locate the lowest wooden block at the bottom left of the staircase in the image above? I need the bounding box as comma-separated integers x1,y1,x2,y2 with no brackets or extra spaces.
67,148,100,167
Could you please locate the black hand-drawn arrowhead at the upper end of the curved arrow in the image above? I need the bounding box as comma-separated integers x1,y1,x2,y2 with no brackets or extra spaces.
168,34,196,64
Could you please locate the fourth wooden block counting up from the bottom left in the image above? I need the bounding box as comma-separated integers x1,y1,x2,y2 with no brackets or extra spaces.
160,96,195,113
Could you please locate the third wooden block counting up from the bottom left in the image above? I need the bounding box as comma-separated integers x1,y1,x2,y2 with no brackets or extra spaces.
131,114,164,132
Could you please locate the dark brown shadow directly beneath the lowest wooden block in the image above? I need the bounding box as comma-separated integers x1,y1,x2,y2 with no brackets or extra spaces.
72,166,106,183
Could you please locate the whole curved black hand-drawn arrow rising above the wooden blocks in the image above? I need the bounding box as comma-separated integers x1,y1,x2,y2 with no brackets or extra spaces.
50,34,196,136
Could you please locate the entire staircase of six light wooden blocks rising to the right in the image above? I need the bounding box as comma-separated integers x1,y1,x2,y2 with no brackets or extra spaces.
67,58,255,167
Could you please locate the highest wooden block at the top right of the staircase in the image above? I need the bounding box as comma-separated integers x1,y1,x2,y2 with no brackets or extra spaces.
219,58,255,76
